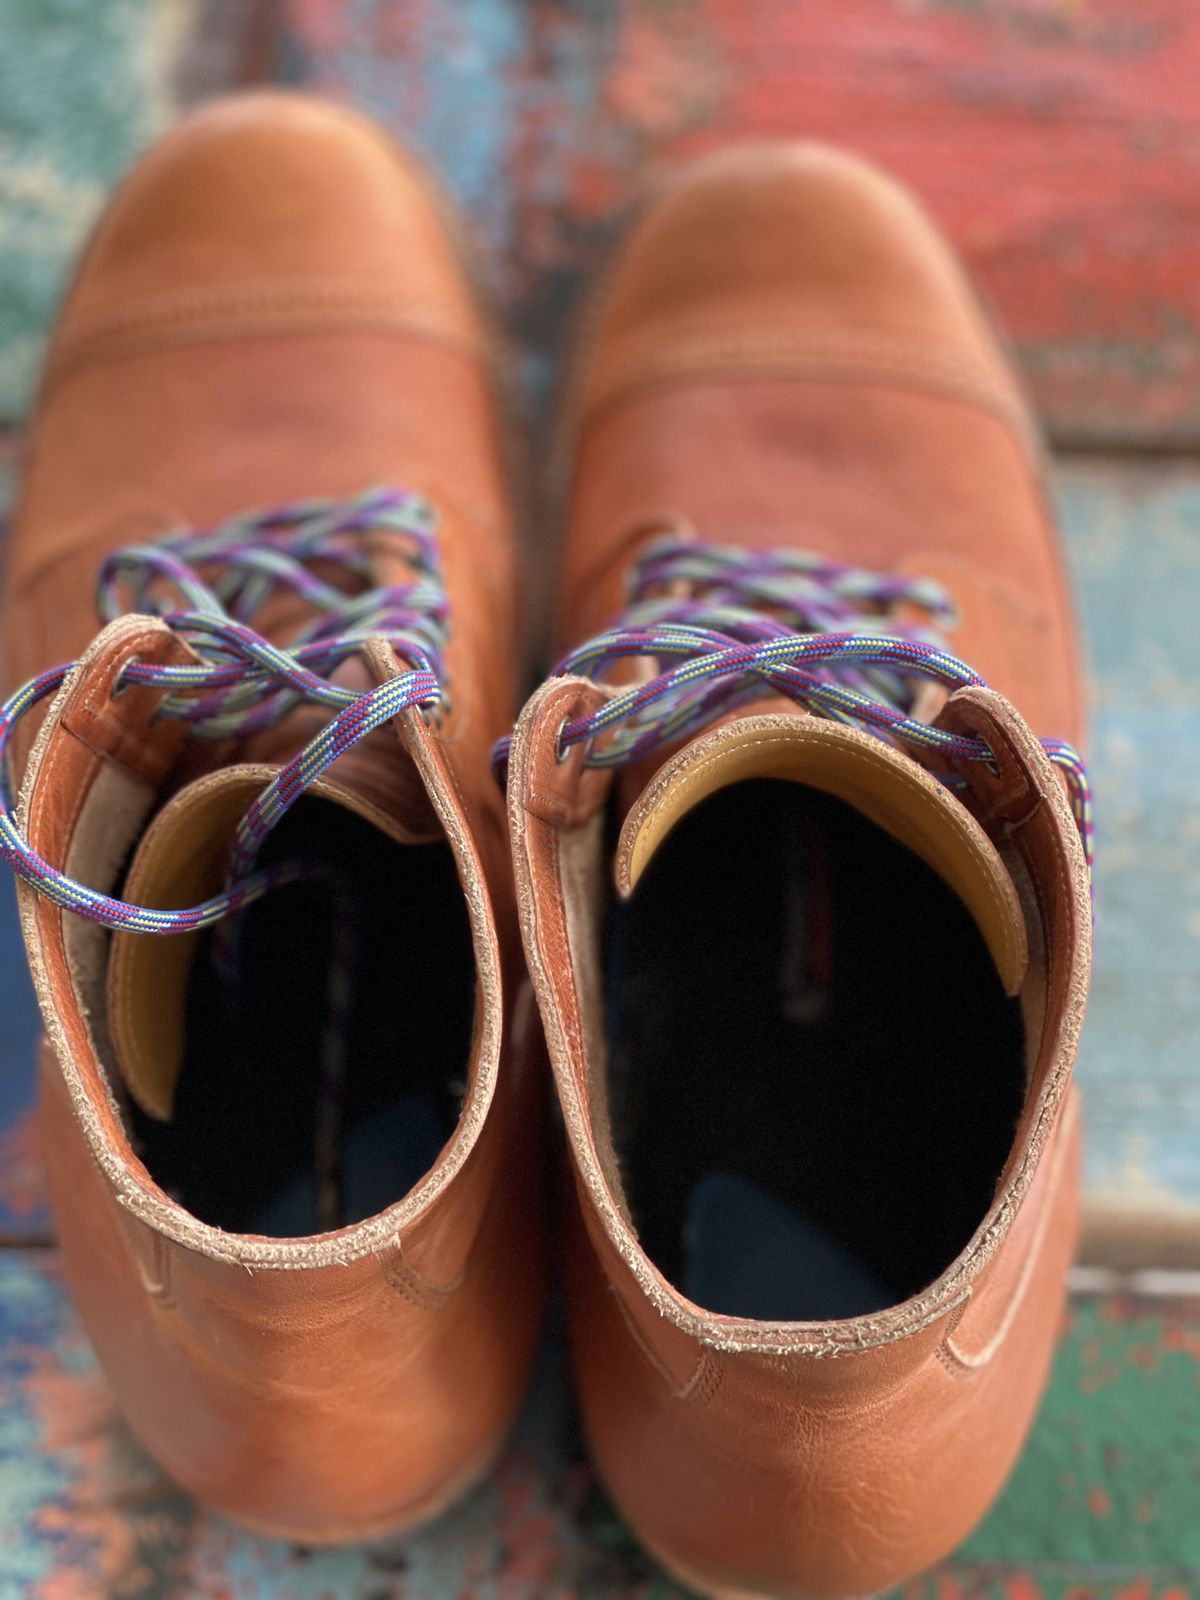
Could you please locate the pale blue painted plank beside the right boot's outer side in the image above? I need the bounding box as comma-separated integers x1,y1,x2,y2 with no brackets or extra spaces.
1058,466,1200,1213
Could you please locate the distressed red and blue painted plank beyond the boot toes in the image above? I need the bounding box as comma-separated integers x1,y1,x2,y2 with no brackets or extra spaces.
280,0,1200,445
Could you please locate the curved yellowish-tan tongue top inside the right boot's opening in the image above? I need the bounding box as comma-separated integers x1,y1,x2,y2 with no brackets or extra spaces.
616,714,1029,995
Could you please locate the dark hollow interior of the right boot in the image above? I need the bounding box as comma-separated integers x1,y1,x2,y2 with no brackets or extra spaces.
606,779,1026,1322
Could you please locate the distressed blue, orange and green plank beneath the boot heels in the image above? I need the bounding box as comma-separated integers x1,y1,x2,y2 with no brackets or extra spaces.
0,1251,1200,1600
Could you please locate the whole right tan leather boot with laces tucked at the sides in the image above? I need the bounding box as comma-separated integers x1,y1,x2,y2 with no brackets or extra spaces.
509,147,1090,1597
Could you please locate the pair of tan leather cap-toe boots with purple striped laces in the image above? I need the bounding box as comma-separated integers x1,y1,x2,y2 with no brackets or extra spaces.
0,93,1091,1597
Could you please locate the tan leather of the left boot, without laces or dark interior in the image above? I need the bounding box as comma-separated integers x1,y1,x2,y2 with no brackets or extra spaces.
5,94,542,1541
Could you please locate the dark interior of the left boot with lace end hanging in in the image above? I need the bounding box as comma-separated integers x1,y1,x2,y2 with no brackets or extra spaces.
131,797,475,1237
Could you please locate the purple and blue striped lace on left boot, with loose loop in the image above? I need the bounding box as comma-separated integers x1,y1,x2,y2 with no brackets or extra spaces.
0,488,448,933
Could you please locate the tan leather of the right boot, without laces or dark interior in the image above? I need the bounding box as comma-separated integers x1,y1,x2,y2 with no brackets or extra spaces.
509,147,1091,1600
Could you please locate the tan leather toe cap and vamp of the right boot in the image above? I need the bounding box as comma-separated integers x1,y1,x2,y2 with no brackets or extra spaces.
555,146,1082,741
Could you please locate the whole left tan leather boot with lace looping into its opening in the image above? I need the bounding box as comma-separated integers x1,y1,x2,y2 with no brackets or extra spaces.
3,94,542,1541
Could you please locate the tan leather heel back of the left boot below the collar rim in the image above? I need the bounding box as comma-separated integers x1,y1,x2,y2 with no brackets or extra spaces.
42,1058,536,1542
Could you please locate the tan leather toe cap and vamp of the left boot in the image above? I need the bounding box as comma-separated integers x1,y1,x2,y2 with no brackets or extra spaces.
5,93,517,790
